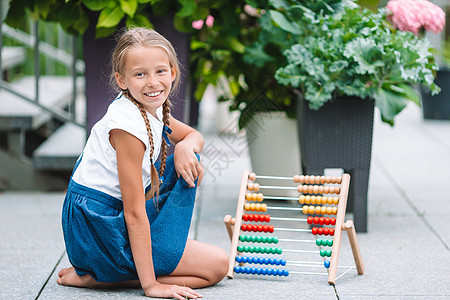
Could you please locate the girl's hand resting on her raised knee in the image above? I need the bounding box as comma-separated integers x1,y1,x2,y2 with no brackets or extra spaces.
174,141,204,187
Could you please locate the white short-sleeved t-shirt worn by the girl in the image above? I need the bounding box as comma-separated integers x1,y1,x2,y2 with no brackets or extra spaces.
72,95,163,200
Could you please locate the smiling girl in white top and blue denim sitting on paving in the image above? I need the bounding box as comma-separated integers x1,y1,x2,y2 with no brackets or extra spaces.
58,28,228,299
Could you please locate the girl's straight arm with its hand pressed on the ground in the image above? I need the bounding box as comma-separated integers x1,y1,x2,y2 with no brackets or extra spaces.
110,129,199,300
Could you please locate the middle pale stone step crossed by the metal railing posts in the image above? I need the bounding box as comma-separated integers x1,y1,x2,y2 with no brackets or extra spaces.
0,76,85,131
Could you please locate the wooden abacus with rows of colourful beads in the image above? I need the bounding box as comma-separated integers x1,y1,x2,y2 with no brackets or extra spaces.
224,171,364,285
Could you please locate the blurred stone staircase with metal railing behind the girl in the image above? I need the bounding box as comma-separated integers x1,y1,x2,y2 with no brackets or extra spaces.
0,24,86,191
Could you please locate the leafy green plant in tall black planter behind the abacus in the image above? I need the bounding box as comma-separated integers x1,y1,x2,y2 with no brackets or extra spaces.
266,2,439,232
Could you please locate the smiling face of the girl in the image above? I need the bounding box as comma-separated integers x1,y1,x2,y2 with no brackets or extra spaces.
115,47,177,117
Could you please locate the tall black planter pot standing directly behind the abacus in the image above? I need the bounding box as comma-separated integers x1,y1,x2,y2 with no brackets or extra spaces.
297,96,374,232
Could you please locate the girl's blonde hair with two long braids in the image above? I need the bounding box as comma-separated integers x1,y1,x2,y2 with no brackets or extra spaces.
110,27,180,200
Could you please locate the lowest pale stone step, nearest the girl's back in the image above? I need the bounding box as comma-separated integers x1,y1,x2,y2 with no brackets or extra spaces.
33,123,86,171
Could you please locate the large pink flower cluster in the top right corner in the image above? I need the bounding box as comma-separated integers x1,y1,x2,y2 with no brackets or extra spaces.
386,0,445,35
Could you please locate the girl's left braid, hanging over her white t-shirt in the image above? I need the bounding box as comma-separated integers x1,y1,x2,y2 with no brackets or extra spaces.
122,89,159,207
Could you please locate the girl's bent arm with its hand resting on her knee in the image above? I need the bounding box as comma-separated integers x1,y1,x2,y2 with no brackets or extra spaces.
169,115,205,187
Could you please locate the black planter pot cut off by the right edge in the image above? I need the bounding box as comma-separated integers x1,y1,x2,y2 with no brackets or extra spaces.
421,69,450,120
